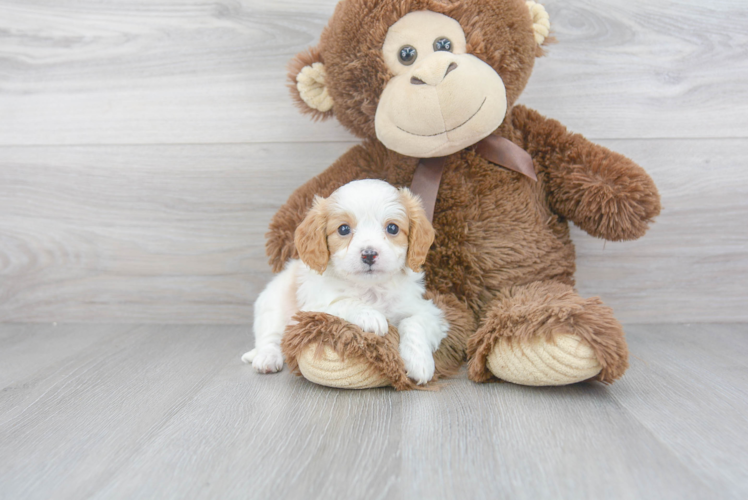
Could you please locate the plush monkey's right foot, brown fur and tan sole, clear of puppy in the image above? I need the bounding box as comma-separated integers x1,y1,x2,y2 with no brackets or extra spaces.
468,281,628,386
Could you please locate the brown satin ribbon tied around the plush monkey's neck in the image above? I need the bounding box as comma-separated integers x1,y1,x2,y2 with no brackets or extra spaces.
410,135,538,221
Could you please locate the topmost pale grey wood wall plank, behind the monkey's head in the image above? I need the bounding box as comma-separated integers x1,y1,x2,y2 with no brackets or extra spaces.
0,0,748,145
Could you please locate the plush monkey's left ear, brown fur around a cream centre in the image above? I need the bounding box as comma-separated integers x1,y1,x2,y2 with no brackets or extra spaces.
288,47,333,120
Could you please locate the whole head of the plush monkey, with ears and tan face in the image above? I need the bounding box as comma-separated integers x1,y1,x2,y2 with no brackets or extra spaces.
289,0,550,154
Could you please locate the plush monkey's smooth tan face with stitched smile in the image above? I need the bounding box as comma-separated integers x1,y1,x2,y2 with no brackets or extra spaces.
375,10,507,158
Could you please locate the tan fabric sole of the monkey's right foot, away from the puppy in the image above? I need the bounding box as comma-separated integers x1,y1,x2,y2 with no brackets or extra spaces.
486,334,602,386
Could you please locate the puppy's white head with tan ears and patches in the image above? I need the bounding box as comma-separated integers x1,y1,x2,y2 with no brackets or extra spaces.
294,179,434,283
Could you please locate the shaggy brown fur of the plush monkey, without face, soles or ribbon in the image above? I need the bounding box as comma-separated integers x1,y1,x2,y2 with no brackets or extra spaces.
267,0,660,388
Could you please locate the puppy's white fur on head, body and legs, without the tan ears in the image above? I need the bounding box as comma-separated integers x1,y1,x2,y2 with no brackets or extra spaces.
243,180,449,384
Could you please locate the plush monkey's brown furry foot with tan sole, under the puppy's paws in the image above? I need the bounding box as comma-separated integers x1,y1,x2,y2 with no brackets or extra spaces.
281,312,416,391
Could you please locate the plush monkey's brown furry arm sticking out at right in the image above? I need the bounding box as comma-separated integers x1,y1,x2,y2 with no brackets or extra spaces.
512,106,660,241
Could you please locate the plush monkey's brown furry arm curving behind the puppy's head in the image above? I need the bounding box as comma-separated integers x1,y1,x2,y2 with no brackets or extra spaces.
265,146,372,273
